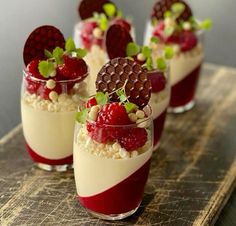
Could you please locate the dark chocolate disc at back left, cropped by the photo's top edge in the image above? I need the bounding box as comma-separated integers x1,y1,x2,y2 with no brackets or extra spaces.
78,0,115,20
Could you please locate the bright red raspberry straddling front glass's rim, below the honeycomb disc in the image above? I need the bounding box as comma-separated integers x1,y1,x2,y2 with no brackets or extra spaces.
87,103,131,143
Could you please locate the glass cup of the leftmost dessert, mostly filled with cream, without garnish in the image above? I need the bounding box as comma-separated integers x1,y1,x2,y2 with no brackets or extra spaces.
21,71,86,171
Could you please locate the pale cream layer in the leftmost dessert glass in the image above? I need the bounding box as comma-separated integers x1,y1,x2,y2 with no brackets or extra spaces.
21,100,75,160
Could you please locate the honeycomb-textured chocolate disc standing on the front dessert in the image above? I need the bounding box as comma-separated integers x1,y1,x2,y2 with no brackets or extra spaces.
96,58,151,108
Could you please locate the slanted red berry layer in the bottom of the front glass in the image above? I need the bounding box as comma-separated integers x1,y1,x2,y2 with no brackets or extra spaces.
78,159,151,215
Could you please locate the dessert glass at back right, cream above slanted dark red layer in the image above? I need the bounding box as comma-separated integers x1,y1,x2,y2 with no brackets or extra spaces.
168,31,204,113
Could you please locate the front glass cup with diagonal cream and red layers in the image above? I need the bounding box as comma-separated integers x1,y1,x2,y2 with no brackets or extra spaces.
73,106,153,220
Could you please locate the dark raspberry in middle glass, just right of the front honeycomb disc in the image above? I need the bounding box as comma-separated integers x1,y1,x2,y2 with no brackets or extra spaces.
148,71,166,93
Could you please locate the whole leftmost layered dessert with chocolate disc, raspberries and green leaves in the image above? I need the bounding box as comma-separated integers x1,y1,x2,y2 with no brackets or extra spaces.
21,26,88,170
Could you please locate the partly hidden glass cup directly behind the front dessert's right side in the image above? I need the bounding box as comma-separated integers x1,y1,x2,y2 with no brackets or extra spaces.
148,67,170,151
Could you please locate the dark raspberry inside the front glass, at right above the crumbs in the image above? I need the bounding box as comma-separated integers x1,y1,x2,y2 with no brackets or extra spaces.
118,128,147,151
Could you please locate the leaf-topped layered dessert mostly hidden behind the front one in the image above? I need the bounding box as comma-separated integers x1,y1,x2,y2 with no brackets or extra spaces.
126,41,171,150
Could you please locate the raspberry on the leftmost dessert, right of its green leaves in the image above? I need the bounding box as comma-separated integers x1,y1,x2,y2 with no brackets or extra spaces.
58,54,88,82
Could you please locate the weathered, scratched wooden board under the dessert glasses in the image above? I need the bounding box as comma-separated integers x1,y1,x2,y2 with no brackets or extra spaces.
0,66,236,226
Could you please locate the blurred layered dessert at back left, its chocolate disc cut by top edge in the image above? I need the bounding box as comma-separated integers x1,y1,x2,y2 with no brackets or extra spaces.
74,0,134,95
